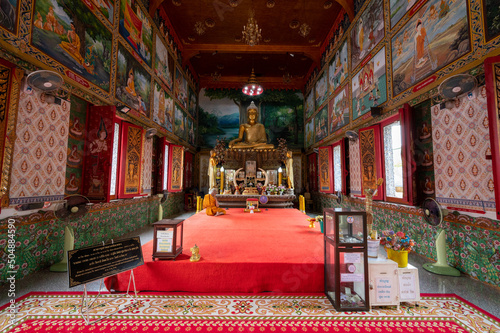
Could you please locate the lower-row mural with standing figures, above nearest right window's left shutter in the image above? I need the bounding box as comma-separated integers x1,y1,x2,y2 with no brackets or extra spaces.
352,47,387,119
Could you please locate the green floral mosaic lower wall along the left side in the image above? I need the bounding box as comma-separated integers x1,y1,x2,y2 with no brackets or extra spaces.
0,193,184,284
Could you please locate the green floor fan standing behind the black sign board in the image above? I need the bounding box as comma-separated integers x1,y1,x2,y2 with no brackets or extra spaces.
50,194,90,272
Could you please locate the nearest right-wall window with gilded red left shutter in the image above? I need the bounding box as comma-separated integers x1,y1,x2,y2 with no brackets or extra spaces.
359,105,413,204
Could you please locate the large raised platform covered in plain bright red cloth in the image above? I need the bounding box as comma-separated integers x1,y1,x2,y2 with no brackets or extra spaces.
105,208,324,293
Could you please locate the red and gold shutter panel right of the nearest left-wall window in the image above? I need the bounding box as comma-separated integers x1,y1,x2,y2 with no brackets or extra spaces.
118,121,143,198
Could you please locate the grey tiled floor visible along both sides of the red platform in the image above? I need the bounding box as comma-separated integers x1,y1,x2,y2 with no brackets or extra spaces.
0,213,500,318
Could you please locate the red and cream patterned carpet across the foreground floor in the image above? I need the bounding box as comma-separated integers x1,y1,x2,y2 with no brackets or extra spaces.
0,292,500,333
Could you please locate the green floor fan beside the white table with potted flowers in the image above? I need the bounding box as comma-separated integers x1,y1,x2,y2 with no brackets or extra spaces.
422,198,460,276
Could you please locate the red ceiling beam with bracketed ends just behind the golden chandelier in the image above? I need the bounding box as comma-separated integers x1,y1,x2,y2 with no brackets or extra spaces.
182,44,321,66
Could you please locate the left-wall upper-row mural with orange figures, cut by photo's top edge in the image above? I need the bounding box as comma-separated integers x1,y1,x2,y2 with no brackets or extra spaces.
120,0,153,67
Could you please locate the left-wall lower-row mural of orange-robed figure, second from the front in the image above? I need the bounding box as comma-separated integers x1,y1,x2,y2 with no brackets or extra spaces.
116,43,151,118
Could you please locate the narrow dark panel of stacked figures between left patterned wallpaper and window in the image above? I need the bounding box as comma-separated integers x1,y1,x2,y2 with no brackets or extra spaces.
65,96,87,195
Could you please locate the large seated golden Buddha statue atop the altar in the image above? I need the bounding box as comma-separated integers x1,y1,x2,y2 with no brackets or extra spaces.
229,102,274,149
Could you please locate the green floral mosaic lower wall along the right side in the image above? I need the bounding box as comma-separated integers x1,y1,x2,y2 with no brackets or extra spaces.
313,193,500,287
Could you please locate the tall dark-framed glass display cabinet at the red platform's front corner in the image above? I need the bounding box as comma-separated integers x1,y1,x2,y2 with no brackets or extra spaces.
323,208,370,311
